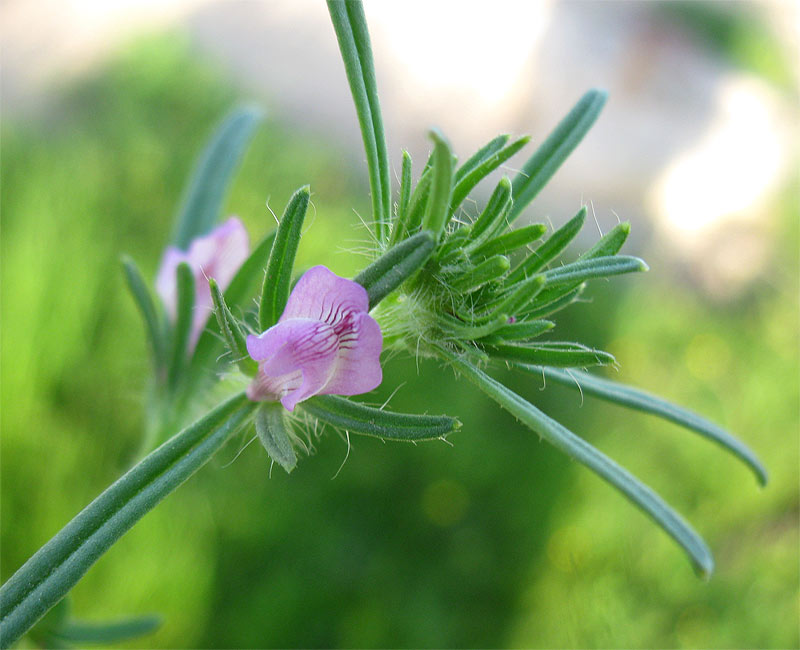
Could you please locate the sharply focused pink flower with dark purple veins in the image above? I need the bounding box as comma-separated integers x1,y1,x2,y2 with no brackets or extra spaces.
247,266,383,411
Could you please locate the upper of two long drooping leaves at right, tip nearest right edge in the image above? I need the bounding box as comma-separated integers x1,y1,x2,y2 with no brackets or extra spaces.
518,365,768,485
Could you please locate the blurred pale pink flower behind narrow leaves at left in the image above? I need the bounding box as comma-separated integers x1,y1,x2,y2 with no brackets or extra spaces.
156,217,250,353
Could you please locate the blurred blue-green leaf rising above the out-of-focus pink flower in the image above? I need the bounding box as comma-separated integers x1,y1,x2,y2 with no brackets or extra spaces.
172,107,263,250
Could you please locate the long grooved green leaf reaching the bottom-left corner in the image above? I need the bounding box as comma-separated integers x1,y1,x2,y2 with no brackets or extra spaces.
0,393,256,648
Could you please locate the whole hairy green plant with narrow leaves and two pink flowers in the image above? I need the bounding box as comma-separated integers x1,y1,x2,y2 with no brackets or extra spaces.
0,0,766,647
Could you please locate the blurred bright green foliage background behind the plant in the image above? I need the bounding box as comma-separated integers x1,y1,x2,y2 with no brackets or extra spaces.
0,7,800,648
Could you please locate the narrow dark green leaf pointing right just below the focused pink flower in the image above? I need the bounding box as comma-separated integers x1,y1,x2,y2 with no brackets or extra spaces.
300,395,461,440
